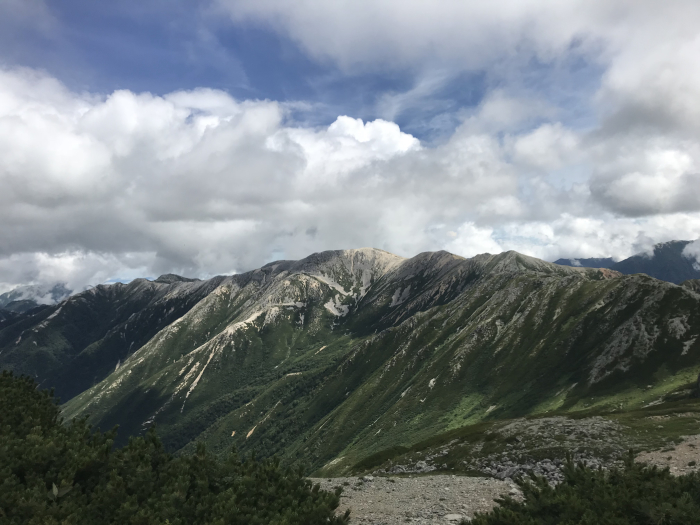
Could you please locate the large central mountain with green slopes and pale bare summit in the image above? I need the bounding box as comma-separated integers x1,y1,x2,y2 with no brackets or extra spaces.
6,249,700,474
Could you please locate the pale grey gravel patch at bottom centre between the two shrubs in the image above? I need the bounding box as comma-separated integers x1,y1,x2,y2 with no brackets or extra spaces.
312,475,520,525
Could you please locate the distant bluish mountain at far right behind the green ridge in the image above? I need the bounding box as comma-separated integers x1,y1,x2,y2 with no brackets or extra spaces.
555,241,700,284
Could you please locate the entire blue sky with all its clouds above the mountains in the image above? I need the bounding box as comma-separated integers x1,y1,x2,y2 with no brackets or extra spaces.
0,0,700,292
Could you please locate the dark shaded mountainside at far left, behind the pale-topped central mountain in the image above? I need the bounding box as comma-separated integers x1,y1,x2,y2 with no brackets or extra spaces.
0,276,221,400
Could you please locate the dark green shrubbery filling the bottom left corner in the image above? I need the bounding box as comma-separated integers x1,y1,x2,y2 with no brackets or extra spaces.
0,372,349,525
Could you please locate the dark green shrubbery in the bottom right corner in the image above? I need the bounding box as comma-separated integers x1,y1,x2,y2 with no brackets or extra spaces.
470,455,700,525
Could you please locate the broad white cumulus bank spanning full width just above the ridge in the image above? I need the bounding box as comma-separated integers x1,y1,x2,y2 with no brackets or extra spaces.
0,61,700,289
